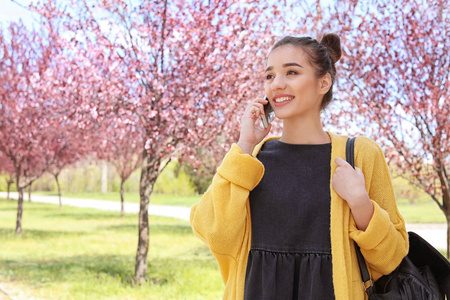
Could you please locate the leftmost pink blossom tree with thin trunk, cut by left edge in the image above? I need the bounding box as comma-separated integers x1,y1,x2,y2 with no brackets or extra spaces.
0,22,96,234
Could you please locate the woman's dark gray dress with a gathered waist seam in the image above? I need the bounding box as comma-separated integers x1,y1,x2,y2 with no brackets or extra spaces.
244,139,334,300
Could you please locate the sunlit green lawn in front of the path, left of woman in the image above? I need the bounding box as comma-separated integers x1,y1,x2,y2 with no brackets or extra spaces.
0,199,224,299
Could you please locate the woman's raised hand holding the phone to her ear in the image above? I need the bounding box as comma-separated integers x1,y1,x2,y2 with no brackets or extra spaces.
237,99,271,155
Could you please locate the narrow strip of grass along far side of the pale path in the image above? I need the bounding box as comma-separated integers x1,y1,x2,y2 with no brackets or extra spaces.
31,192,201,207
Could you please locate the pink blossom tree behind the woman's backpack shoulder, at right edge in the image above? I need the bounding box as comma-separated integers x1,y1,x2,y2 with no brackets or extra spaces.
329,0,450,256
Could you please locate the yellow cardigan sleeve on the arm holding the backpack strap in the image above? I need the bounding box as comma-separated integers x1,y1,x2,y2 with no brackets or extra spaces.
350,137,409,280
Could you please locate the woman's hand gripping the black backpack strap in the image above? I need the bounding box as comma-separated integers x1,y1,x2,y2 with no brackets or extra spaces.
331,157,374,230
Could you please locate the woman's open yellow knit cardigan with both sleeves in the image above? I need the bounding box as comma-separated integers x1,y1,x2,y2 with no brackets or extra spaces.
190,132,409,300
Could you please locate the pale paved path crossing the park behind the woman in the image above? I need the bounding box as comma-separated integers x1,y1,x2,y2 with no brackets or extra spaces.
0,192,447,250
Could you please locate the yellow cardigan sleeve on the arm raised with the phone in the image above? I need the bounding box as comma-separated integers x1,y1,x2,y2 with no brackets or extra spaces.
190,144,264,258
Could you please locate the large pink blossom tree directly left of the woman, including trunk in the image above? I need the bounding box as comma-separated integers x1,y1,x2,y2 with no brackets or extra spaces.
34,0,302,284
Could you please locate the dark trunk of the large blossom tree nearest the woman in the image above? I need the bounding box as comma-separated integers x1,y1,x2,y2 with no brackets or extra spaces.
134,150,160,285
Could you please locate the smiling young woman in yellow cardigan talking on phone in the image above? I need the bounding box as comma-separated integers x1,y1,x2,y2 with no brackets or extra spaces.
191,34,409,300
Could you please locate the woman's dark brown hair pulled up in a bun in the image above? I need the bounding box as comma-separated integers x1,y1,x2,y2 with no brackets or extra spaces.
271,33,342,109
